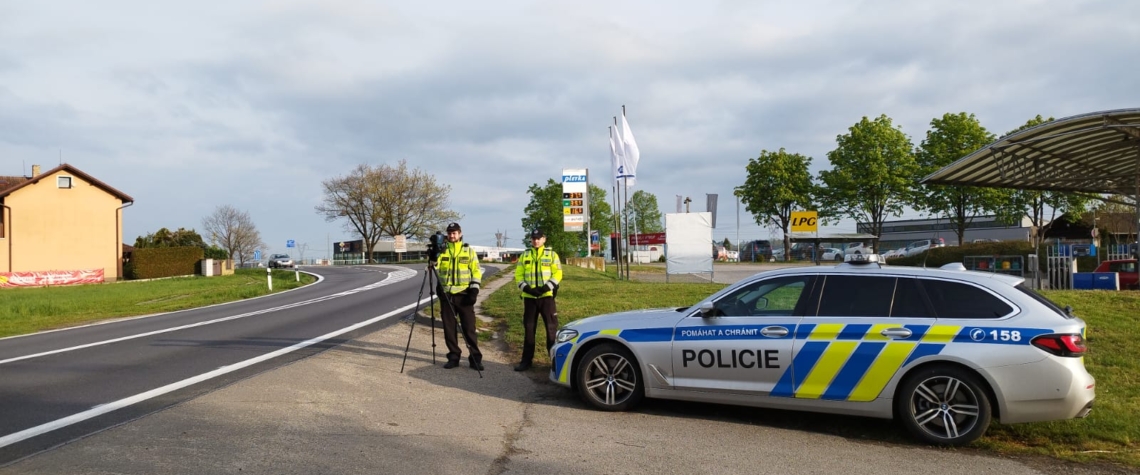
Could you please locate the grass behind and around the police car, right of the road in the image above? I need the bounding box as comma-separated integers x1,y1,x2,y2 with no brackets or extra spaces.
483,267,1140,467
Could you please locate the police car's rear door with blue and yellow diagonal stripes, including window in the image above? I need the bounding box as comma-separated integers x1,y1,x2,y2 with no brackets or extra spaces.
772,275,934,402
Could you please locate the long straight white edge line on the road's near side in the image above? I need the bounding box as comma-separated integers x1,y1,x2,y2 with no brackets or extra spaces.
0,290,432,448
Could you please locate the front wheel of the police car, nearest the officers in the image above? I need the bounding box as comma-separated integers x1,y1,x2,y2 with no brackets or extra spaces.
576,343,644,411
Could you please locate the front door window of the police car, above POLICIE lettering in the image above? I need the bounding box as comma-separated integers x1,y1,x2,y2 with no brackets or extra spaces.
715,276,809,317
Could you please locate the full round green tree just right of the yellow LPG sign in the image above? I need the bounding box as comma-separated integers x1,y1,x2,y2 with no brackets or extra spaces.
817,115,918,246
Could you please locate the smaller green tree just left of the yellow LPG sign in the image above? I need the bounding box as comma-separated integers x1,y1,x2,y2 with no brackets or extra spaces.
733,148,815,255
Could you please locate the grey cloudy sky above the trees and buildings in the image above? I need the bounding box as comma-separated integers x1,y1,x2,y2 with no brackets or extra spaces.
0,0,1140,257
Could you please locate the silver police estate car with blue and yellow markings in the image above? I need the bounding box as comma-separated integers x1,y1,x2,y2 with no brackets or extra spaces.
549,254,1094,445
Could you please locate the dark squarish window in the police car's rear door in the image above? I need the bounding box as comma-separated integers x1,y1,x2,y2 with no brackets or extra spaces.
817,276,895,317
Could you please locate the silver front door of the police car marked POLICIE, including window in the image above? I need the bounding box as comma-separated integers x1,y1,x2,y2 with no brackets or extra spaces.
673,276,815,395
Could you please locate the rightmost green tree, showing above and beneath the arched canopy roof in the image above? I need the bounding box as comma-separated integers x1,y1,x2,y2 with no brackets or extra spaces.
1007,115,1092,247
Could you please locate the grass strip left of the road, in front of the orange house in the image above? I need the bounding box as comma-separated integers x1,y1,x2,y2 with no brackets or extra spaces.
0,269,316,337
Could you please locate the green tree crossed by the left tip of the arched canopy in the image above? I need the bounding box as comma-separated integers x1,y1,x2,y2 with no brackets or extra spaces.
913,112,1013,243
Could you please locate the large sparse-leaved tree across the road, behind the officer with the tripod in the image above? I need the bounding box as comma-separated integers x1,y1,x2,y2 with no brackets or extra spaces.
316,161,459,260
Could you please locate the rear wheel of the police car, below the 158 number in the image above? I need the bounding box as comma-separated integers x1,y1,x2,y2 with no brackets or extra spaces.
895,367,992,445
